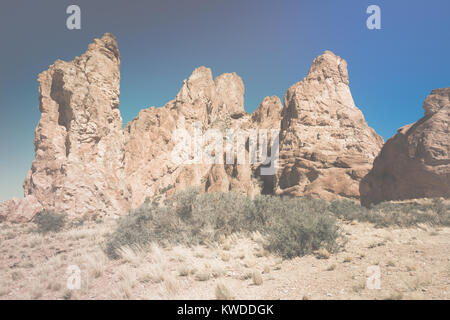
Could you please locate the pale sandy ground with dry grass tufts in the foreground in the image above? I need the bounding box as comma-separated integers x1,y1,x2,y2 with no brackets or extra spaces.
0,220,450,299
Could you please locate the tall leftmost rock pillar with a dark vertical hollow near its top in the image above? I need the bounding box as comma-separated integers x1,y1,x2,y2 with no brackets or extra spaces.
24,34,130,215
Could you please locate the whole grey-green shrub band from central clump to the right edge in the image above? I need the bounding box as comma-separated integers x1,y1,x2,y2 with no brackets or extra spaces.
105,188,450,260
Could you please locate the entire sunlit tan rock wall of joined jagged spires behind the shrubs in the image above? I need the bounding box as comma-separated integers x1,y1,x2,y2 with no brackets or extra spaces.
6,34,382,220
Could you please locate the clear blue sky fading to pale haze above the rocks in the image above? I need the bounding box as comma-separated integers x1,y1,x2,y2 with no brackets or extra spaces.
0,0,450,201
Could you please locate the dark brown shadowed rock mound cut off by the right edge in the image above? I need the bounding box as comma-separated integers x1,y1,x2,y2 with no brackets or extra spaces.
360,88,450,205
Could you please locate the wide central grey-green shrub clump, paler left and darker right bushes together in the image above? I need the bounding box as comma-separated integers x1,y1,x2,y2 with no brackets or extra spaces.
105,189,341,258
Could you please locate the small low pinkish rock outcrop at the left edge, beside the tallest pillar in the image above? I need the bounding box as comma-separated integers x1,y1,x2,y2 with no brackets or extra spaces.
0,195,43,223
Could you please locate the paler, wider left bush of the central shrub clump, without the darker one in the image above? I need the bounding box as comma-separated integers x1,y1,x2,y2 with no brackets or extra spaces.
105,189,253,258
